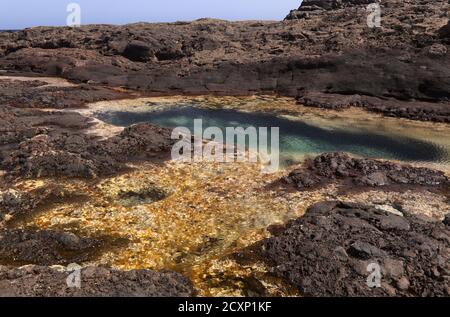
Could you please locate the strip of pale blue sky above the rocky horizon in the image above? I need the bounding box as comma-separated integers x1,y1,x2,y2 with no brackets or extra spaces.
0,0,301,29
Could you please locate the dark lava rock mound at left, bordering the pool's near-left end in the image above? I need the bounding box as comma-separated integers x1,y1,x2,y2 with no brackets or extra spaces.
2,123,173,178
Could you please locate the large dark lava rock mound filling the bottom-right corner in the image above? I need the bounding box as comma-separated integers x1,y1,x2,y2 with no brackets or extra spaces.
251,201,450,296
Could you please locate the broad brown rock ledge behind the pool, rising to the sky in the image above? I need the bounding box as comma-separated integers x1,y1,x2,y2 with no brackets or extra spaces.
0,0,450,122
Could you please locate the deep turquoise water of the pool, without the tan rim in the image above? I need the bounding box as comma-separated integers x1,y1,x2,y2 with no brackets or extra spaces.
97,106,450,165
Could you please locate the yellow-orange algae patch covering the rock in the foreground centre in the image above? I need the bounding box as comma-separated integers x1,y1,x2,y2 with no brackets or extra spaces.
12,161,325,295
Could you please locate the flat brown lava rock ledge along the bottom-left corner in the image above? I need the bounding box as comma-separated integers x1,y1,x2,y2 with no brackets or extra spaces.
0,266,194,297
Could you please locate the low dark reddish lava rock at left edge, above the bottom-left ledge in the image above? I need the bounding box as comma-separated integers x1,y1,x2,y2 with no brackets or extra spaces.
0,229,100,266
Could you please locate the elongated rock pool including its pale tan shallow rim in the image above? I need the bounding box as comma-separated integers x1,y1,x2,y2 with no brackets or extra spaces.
94,100,450,166
